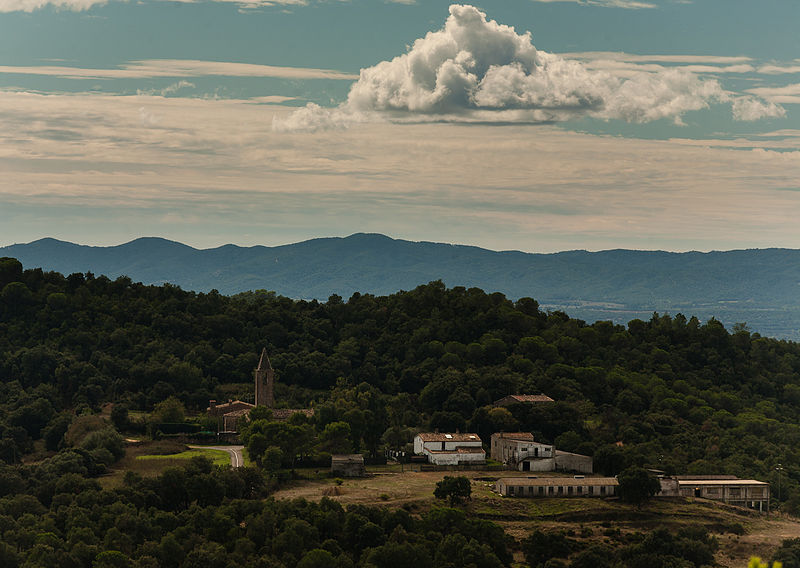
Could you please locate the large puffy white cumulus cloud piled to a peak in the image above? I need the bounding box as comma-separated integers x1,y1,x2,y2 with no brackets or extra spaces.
274,5,780,130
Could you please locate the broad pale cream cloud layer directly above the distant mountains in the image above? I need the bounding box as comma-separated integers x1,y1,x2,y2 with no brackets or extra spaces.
0,90,800,251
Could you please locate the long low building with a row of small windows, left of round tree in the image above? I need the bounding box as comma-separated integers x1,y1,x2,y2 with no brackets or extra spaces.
495,476,619,497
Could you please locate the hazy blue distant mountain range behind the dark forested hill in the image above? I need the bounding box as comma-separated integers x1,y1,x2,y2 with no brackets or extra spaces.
0,233,800,340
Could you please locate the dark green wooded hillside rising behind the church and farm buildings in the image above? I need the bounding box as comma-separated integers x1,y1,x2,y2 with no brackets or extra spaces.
0,259,800,492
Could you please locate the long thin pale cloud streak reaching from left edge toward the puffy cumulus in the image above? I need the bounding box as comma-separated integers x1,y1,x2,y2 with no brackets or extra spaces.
0,60,358,80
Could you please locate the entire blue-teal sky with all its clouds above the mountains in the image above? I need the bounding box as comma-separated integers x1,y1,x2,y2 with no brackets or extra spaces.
0,0,800,252
